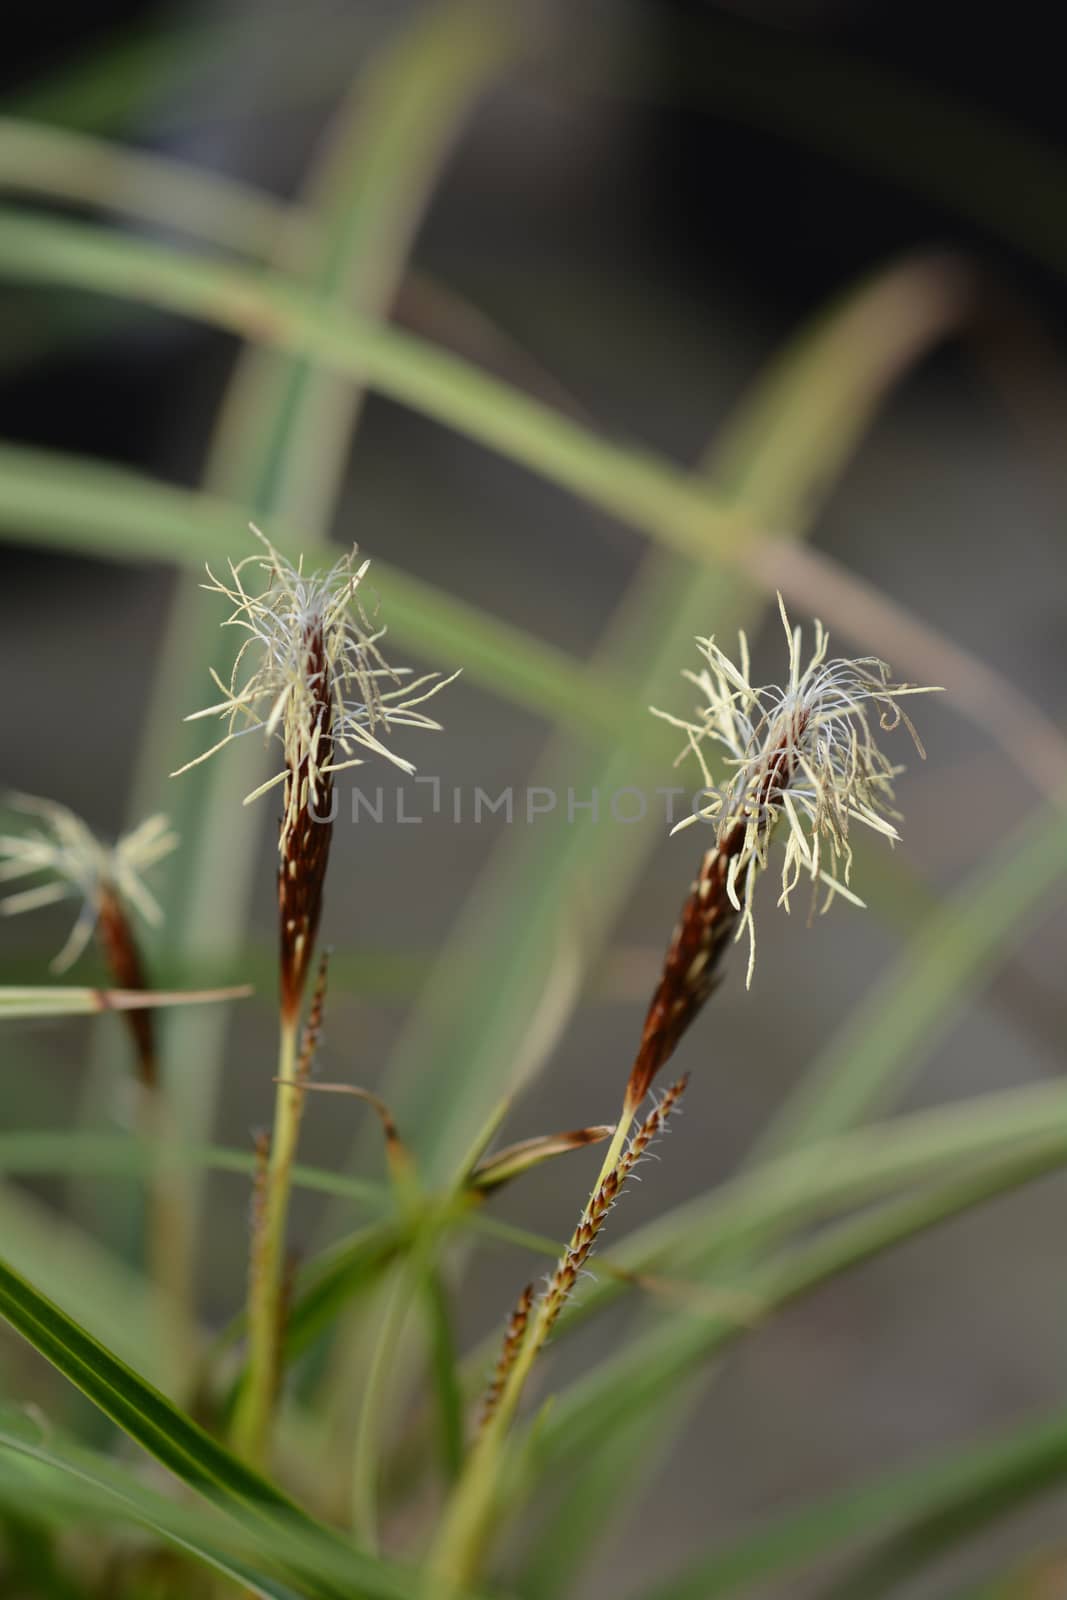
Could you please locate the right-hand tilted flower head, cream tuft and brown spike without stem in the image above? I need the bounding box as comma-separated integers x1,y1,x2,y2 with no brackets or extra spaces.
625,595,933,1115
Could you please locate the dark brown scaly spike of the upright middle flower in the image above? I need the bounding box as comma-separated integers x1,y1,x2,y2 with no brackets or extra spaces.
278,626,333,1021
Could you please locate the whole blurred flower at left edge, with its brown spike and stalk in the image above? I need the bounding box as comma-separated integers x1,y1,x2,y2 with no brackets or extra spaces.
0,794,197,1386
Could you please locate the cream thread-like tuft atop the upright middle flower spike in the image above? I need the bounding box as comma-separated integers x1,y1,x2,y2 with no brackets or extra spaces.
171,525,456,837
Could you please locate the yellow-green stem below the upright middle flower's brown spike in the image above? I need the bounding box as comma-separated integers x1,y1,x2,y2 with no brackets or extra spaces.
234,1013,304,1466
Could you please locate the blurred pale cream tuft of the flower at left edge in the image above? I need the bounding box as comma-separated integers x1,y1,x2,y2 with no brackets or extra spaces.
0,794,178,973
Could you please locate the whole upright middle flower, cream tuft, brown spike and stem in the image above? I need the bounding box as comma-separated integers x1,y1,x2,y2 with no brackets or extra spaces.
179,528,451,1464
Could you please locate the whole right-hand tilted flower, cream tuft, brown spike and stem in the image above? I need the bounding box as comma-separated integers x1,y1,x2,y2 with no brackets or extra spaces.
432,597,928,1595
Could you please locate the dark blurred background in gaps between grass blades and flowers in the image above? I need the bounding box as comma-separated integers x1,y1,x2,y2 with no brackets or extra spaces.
0,0,1067,1600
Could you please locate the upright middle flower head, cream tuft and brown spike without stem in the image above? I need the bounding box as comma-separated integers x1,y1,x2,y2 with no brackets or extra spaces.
173,526,456,1016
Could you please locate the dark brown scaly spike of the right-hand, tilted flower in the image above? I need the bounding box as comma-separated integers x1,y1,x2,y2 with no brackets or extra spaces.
625,715,808,1115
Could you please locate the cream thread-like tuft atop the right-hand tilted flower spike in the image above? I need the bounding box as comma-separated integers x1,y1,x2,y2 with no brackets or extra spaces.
653,595,934,981
